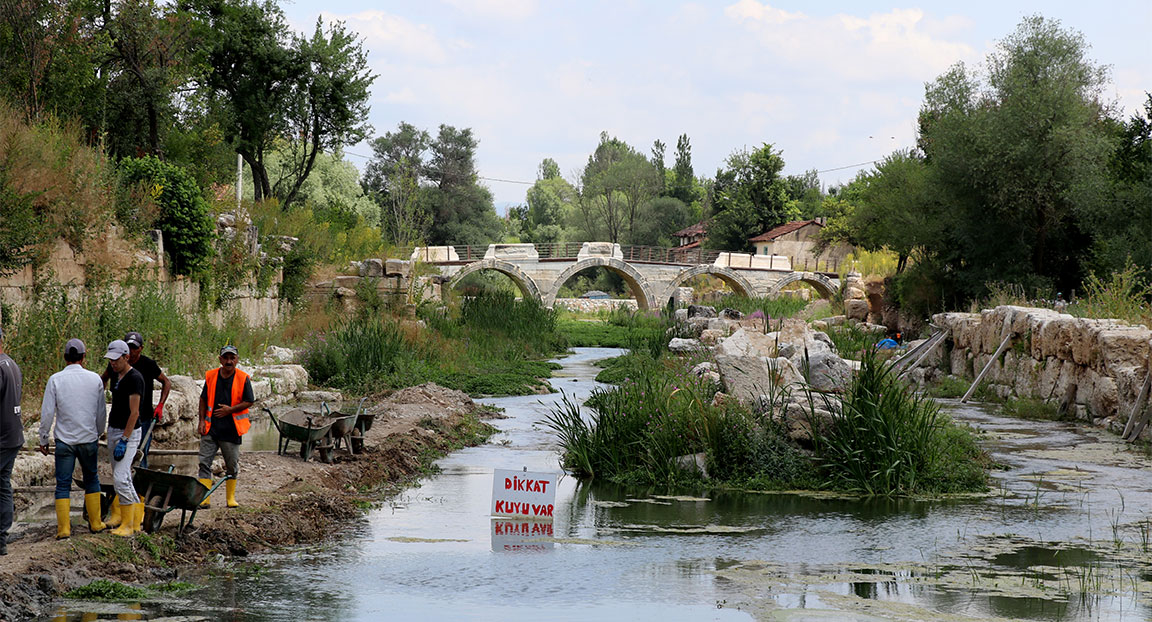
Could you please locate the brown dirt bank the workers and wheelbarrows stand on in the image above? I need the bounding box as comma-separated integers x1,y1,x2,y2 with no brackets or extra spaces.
0,384,501,621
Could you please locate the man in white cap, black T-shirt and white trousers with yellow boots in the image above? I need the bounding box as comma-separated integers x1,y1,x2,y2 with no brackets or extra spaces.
104,339,144,536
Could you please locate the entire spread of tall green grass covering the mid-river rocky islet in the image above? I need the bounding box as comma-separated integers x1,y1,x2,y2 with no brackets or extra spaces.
547,301,988,495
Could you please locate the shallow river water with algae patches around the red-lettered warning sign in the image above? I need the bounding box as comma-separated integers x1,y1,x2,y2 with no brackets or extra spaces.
54,348,1152,622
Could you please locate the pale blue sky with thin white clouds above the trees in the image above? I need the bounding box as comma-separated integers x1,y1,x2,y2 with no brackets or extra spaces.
282,0,1152,213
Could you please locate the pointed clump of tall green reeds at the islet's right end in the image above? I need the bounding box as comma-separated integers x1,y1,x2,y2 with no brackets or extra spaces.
811,350,984,495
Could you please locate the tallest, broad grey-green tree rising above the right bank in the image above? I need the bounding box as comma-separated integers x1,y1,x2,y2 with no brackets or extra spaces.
919,16,1113,298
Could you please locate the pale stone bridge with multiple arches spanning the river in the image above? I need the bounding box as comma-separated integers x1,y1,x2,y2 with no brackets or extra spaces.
411,242,840,309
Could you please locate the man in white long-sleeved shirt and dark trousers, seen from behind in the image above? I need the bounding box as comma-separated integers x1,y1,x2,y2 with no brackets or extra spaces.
40,339,107,540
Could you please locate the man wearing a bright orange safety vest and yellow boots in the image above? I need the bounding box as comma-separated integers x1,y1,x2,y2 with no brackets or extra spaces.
199,344,256,508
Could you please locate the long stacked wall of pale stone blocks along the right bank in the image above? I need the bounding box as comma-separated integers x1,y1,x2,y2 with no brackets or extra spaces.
917,305,1152,438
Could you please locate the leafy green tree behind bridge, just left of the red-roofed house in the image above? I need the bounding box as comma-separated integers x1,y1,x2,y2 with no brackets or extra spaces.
705,144,798,251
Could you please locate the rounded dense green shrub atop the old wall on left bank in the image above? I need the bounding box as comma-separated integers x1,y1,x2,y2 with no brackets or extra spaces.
120,156,215,274
